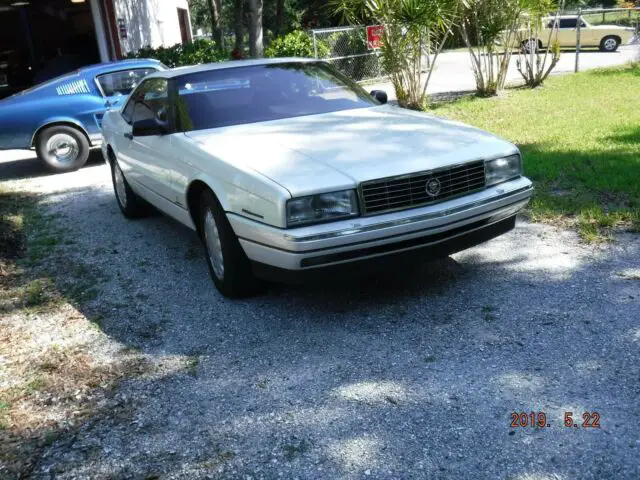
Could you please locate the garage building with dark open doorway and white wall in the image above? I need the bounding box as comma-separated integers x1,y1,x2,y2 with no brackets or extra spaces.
0,0,191,99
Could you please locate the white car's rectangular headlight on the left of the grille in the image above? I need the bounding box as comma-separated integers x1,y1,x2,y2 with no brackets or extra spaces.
287,190,359,227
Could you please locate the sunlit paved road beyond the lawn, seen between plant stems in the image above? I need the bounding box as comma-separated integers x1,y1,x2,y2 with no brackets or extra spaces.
366,45,640,100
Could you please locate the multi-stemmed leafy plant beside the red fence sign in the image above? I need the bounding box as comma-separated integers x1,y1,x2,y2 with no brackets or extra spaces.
329,0,461,110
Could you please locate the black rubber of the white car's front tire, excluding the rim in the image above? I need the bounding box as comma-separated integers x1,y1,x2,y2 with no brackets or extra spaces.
198,190,257,298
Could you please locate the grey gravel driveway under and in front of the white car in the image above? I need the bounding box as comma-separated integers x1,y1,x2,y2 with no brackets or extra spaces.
0,154,640,480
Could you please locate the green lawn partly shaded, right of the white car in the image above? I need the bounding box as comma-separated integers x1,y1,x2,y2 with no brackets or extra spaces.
432,65,640,241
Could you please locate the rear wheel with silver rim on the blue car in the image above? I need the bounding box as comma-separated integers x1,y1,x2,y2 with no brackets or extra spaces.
35,125,90,173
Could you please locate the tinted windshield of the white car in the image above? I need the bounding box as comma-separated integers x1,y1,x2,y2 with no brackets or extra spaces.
176,62,379,131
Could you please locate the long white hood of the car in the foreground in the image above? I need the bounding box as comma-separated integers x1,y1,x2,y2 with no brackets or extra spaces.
186,105,517,197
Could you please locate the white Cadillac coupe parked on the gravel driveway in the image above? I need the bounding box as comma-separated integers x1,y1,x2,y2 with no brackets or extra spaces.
102,59,533,297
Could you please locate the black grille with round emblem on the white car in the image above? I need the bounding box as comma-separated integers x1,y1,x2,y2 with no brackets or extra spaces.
360,161,485,215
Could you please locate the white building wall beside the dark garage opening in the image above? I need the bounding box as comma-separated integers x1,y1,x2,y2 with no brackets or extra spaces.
113,0,190,55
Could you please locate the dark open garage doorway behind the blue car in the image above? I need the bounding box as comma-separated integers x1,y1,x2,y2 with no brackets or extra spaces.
0,0,100,98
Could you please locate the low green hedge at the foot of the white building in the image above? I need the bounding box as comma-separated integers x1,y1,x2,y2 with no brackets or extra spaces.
127,39,230,68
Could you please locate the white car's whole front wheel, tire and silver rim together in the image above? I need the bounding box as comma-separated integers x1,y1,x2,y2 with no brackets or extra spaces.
198,190,259,298
